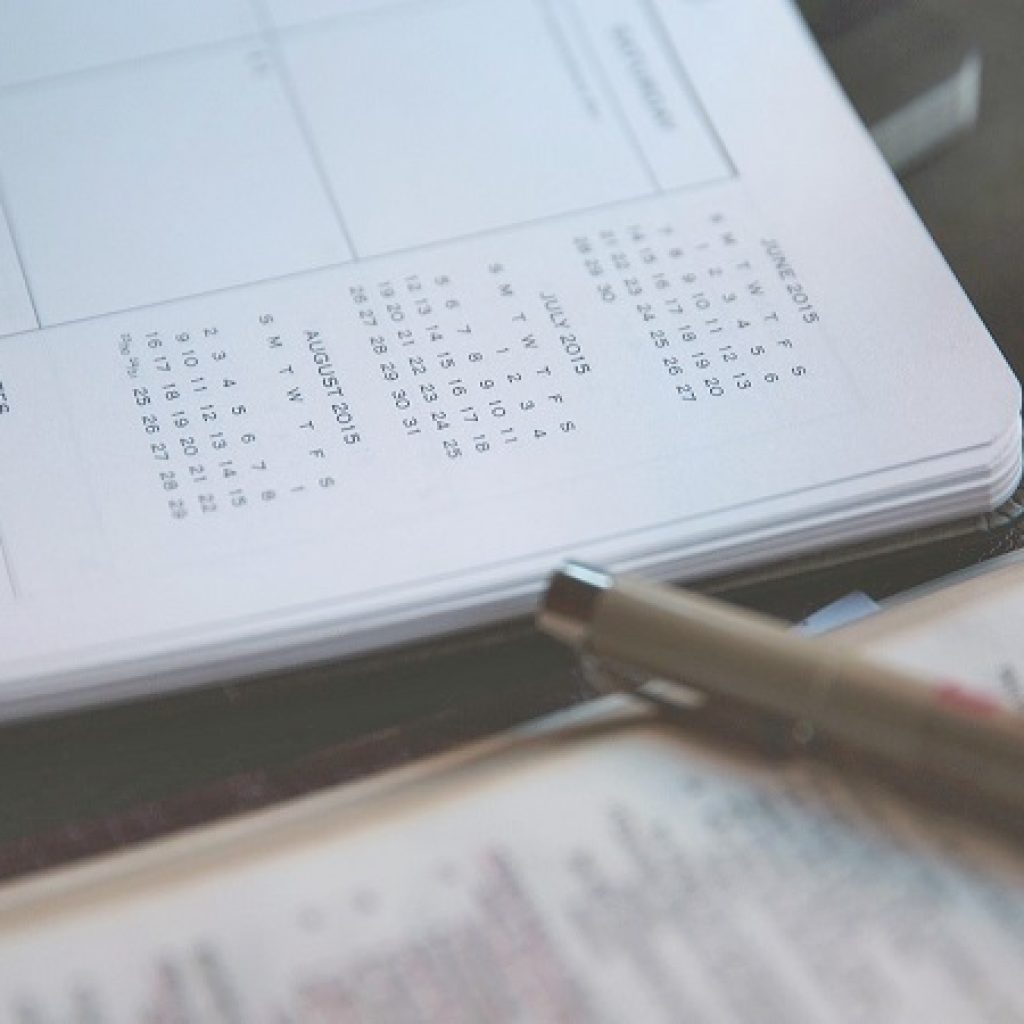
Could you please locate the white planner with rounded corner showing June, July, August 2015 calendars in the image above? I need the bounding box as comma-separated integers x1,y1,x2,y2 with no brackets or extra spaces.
0,0,1021,716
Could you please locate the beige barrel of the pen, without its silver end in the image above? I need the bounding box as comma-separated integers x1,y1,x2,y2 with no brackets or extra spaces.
588,578,1024,812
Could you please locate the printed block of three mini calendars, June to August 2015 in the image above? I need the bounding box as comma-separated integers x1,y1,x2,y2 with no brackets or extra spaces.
96,187,836,536
